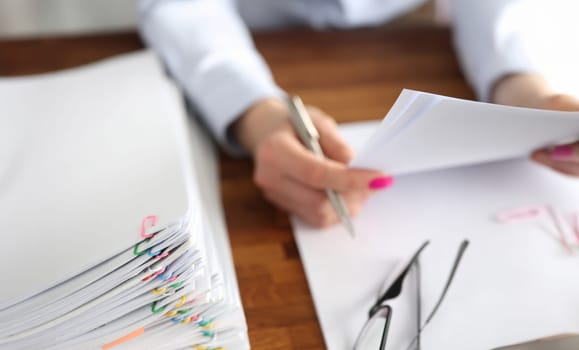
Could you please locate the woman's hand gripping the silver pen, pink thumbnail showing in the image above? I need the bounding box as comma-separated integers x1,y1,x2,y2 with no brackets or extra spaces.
235,98,393,227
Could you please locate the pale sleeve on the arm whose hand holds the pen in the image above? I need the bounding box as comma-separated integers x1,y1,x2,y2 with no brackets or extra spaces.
140,0,283,153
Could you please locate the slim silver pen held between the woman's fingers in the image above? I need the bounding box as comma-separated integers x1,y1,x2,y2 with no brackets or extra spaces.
288,96,355,237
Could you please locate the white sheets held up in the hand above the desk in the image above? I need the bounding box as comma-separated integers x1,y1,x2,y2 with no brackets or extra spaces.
352,90,579,175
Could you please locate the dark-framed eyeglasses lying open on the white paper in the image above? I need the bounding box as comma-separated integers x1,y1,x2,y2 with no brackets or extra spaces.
354,240,469,350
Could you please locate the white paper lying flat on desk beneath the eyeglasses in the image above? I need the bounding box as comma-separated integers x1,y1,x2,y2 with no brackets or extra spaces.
292,116,579,350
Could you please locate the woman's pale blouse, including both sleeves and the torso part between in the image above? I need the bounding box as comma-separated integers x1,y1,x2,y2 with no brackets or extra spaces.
141,0,579,153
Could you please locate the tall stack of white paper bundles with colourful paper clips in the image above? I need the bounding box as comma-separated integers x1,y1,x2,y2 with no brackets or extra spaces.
0,53,248,349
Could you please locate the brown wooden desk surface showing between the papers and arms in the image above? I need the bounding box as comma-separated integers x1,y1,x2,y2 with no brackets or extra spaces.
0,27,472,350
